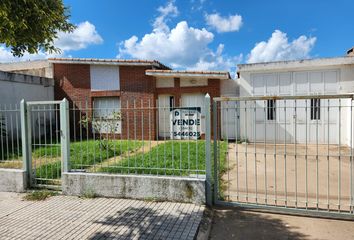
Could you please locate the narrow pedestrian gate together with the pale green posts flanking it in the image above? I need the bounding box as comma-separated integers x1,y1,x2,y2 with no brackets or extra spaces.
21,99,69,189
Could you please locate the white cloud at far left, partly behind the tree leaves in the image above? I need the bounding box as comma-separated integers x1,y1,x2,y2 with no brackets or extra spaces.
0,21,103,62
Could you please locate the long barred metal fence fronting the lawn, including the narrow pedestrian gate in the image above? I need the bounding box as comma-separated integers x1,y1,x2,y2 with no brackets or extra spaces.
0,98,210,188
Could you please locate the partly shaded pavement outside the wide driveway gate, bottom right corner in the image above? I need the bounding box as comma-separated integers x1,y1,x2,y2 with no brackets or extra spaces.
210,207,354,240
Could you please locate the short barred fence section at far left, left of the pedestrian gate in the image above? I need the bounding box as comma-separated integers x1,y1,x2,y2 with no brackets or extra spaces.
0,104,22,168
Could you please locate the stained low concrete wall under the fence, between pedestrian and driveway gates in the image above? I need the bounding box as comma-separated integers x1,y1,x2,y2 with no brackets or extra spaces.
62,172,205,204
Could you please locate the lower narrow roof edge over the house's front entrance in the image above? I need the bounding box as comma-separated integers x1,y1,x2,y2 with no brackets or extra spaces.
145,69,231,79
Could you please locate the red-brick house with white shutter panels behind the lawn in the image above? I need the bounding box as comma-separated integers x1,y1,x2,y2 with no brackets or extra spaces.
0,58,237,139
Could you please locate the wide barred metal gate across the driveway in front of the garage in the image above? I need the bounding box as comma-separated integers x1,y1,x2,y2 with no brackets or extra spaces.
213,94,354,217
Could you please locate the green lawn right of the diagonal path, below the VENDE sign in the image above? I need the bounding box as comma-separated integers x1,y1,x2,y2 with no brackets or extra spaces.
98,140,227,176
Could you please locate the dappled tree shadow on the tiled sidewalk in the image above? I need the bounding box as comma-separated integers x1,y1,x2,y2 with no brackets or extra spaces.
90,207,201,239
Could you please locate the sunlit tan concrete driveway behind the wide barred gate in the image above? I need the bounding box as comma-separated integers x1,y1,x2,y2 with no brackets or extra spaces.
223,143,351,211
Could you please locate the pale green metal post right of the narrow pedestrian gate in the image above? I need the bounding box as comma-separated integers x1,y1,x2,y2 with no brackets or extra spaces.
60,98,70,172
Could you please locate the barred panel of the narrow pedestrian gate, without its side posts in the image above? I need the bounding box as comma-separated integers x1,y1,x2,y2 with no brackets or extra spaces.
24,101,64,188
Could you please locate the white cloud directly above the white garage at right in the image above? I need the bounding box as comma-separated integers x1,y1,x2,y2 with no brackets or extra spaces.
247,30,316,63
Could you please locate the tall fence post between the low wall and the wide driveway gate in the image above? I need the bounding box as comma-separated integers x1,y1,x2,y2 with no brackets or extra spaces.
204,94,212,206
